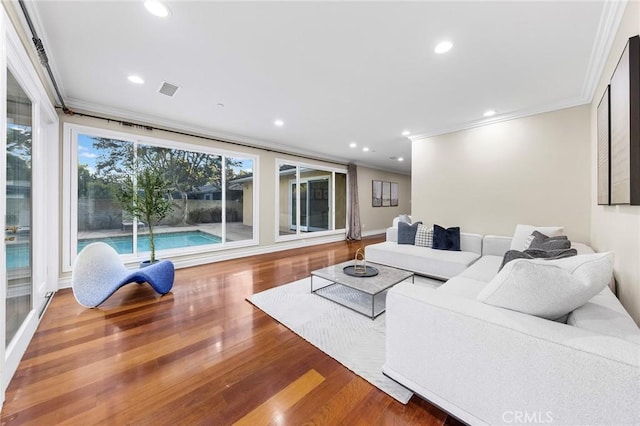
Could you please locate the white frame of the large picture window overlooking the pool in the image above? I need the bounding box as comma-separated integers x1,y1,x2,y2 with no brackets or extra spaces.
62,123,260,272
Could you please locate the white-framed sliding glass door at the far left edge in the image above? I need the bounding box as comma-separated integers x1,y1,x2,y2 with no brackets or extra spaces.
0,8,60,403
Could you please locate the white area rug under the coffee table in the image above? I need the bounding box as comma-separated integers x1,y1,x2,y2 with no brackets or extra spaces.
248,278,440,404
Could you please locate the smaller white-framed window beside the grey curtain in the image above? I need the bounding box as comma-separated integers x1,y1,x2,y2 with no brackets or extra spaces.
276,161,347,239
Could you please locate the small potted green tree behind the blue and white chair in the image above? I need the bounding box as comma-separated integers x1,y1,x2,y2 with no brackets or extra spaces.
118,169,173,263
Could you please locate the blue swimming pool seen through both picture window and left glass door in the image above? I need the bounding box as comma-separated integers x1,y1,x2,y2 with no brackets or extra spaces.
6,231,222,269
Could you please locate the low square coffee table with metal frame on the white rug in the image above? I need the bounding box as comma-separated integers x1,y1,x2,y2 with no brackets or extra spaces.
311,260,413,319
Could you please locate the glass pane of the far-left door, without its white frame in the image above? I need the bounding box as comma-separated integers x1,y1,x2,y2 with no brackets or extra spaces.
4,70,33,347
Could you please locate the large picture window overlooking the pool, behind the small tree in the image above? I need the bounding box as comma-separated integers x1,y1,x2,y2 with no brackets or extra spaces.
65,126,256,266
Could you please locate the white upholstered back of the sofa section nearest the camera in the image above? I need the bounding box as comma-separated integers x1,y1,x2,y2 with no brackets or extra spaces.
383,283,640,424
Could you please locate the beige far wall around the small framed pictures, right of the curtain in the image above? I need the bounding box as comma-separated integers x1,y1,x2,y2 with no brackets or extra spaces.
358,166,411,236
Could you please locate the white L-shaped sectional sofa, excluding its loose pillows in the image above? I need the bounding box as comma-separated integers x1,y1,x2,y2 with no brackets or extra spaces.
380,235,640,425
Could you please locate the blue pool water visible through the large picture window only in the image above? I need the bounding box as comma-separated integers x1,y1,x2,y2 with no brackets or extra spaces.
78,231,222,254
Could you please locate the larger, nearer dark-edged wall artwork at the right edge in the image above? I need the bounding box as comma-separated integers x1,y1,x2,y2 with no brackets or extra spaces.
598,36,640,205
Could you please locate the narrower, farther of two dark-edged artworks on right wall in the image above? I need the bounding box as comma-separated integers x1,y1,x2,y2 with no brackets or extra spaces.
597,86,611,206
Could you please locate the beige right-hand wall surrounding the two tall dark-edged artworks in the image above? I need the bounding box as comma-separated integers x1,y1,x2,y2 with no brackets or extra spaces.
590,1,640,325
